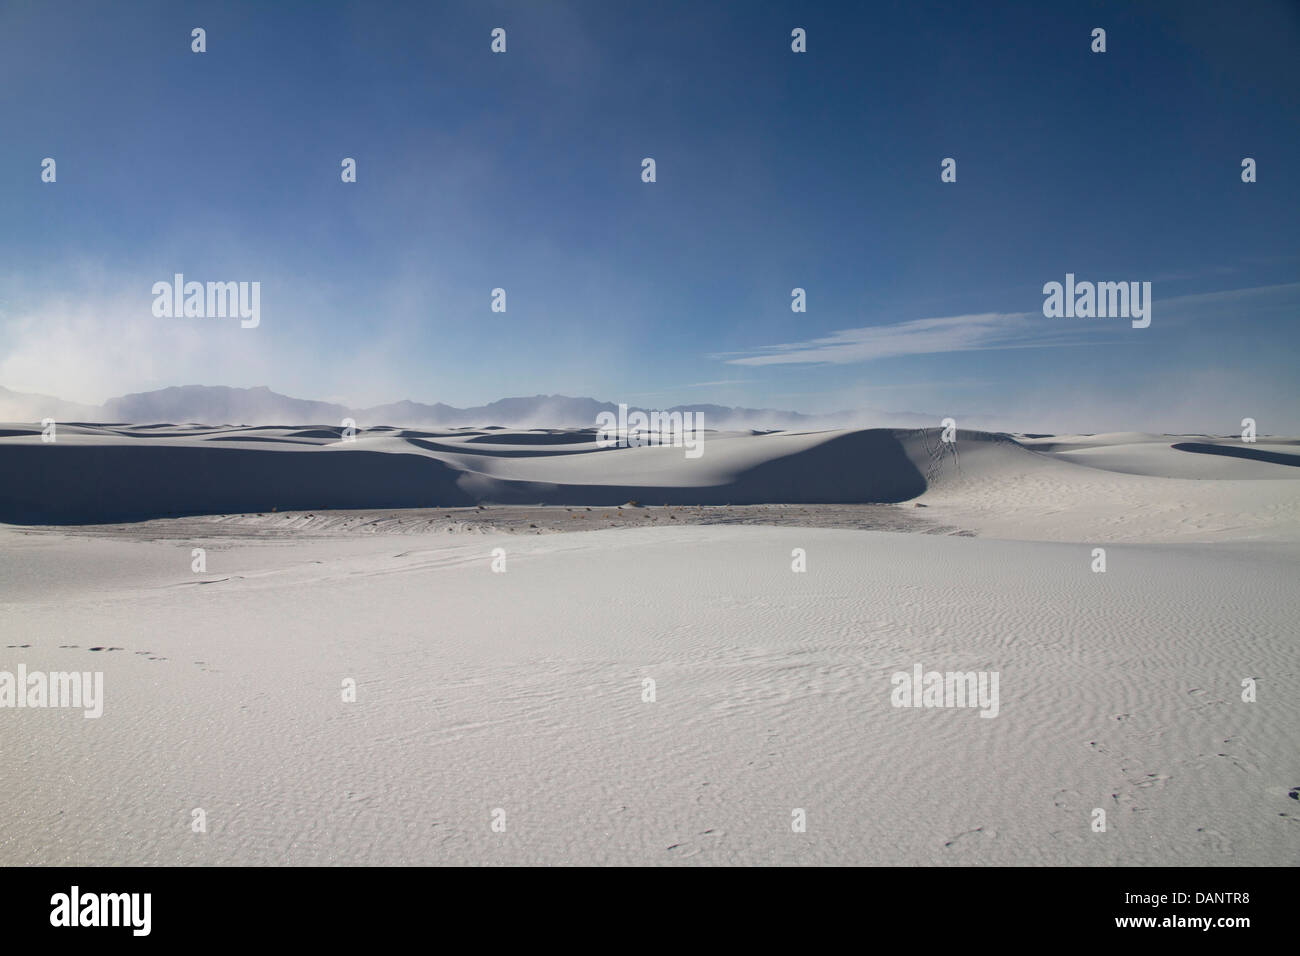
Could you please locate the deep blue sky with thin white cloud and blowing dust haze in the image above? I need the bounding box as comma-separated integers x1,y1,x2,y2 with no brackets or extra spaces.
0,0,1300,432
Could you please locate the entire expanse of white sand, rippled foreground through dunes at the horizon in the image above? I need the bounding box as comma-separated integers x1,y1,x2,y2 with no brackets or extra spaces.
0,425,1300,866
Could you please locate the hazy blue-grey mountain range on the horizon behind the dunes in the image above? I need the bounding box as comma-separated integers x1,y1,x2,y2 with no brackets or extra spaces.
0,385,956,429
